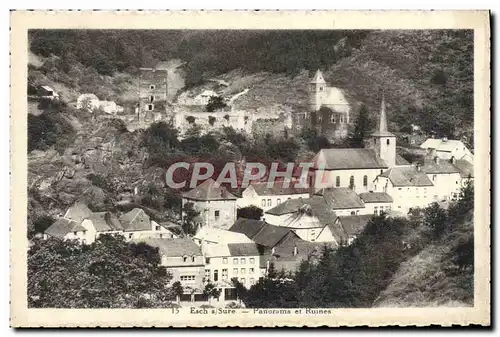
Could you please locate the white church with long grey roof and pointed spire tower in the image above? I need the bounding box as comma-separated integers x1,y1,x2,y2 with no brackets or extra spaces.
310,99,410,193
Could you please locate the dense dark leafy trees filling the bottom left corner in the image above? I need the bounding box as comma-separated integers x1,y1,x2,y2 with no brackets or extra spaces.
28,235,173,308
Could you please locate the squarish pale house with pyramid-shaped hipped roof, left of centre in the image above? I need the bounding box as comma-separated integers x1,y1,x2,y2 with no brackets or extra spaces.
182,178,237,229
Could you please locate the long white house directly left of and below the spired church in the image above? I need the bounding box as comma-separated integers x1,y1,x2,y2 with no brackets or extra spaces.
238,181,309,211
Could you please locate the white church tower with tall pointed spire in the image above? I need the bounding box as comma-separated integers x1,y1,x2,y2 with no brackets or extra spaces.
371,96,396,168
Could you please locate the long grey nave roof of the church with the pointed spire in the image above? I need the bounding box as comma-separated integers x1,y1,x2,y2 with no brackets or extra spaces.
314,149,388,170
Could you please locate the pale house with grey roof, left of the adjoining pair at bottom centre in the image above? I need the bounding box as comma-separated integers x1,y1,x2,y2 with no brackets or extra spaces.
134,238,205,300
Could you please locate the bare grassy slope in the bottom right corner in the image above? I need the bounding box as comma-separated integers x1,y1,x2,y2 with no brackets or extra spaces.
374,214,474,307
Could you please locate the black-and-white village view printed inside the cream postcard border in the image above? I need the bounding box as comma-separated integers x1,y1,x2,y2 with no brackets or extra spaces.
11,9,489,324
